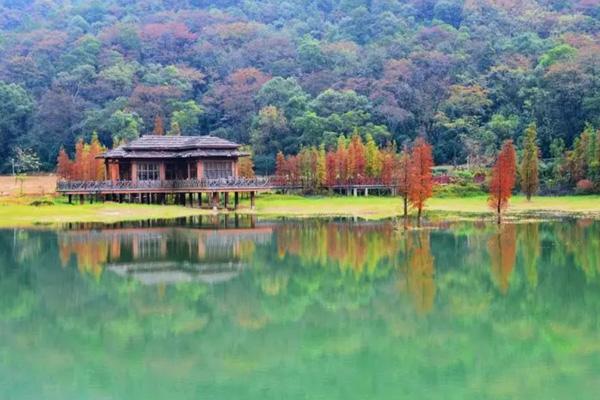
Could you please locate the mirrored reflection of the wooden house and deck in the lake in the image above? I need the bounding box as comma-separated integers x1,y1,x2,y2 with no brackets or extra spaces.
59,217,272,285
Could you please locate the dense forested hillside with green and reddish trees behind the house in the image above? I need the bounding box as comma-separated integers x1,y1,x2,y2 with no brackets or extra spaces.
0,0,600,173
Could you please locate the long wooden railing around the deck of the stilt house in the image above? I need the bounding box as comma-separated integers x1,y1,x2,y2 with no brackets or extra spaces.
56,177,272,193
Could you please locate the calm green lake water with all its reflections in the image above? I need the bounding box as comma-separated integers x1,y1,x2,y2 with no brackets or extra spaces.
0,219,600,400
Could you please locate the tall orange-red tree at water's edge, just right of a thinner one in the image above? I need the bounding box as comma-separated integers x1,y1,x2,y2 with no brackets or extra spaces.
408,138,433,226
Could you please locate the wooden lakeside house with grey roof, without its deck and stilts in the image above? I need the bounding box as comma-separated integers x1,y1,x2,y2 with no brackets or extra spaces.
102,135,249,182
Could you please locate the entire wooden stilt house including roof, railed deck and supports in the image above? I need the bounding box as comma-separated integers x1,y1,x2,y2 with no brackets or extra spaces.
57,135,271,208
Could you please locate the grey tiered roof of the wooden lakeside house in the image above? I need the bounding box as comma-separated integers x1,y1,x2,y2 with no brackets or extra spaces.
102,135,249,158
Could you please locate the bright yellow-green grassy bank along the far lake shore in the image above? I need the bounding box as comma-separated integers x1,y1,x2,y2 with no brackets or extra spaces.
0,195,600,227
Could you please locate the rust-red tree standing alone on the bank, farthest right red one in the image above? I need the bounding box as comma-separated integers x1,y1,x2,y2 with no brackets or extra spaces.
488,140,517,224
